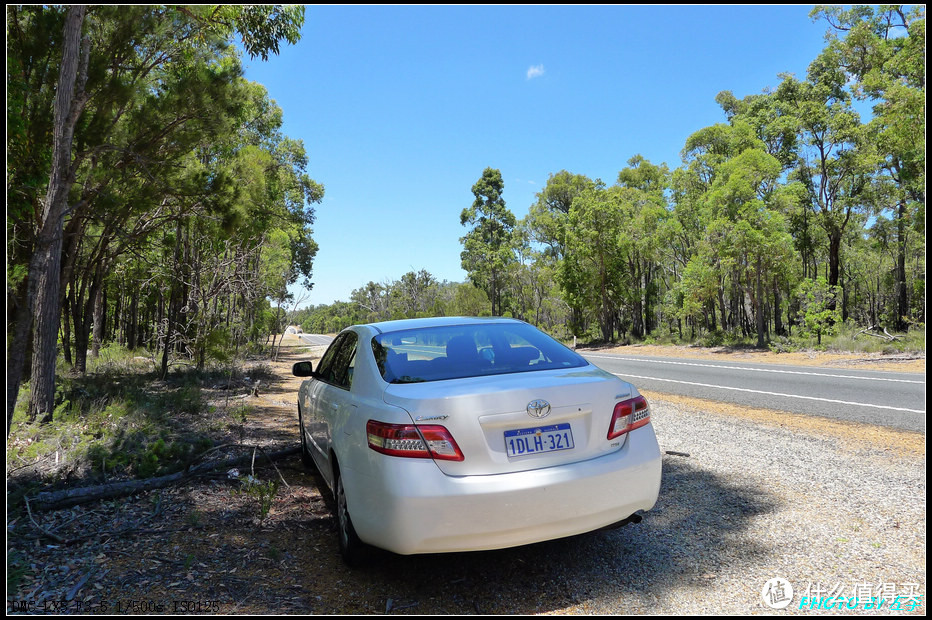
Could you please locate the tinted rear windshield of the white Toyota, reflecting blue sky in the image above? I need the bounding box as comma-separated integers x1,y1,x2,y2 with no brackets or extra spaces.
372,323,588,383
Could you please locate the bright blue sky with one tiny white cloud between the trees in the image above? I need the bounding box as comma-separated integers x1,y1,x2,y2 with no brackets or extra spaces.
238,5,826,306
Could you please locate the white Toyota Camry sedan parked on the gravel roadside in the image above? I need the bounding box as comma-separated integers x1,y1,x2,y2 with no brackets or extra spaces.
293,317,661,564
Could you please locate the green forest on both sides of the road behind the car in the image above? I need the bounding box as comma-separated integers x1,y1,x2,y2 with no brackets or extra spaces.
7,5,926,434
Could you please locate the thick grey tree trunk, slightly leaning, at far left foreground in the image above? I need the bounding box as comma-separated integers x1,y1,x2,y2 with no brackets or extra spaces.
24,5,88,426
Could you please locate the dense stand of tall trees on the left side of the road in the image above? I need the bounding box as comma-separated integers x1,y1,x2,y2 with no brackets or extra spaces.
7,5,323,433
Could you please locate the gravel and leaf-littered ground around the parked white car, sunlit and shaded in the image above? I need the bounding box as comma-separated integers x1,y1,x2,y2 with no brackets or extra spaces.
7,340,926,615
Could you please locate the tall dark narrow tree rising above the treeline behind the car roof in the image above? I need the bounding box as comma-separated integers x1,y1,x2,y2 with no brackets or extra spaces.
460,168,517,316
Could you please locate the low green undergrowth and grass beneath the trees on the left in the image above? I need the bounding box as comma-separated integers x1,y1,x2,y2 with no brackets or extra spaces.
6,345,284,511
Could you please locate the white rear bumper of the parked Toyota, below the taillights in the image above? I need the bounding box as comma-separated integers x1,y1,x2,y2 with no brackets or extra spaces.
343,425,661,555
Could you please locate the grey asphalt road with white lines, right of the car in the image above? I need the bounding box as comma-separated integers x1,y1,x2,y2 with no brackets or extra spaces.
583,353,925,433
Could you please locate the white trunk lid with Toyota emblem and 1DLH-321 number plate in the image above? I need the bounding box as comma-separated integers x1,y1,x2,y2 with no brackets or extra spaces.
383,365,634,476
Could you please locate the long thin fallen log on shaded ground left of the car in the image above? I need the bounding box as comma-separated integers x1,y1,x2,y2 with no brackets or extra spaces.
32,446,301,510
